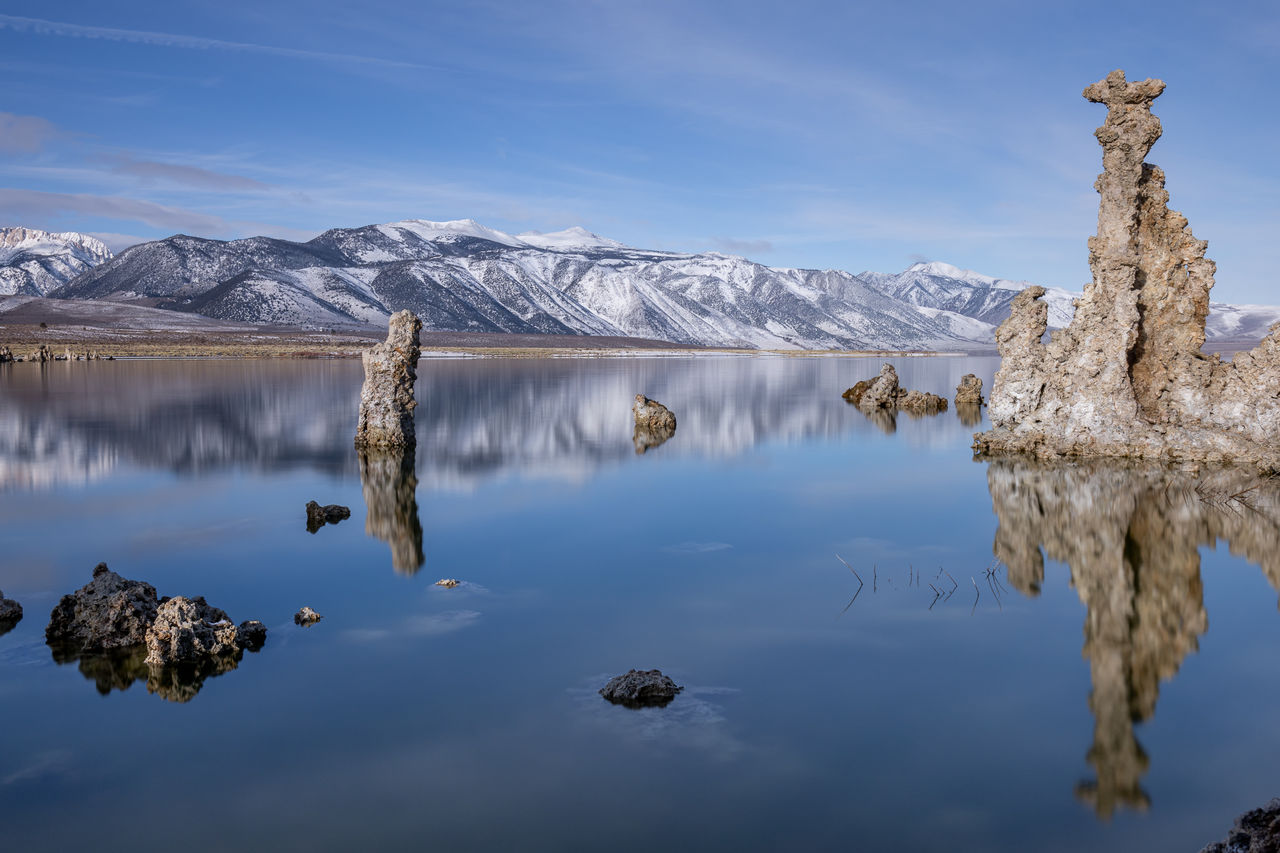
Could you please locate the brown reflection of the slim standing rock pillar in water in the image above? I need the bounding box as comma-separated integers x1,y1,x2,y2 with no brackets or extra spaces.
358,448,426,575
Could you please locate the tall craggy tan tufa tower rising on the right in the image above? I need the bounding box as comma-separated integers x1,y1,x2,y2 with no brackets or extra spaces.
974,70,1280,470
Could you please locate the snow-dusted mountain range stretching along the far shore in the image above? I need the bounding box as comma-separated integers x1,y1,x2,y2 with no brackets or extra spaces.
0,219,1280,350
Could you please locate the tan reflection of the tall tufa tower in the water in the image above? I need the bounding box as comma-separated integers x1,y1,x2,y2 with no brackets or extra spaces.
987,459,1280,817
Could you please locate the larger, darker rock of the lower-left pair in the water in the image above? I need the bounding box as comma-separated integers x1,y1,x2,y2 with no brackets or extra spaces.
45,562,160,650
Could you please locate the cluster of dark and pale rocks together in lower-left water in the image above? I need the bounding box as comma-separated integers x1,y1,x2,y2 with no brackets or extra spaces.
45,562,266,702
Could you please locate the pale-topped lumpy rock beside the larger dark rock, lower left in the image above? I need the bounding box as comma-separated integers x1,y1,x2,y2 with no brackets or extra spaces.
146,596,266,665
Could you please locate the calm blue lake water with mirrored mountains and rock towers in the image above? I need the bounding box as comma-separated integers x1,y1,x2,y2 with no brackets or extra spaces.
0,357,1280,852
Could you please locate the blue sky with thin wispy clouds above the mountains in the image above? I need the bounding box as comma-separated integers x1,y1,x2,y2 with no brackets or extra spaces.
0,0,1280,304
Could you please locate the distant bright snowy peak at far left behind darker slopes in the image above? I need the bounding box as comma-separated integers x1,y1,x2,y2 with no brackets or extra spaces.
0,228,111,296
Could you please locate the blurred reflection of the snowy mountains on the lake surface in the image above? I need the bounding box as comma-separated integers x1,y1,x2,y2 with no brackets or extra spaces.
0,356,996,491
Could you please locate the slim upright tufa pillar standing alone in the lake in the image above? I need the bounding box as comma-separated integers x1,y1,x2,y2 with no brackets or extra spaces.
356,310,422,447
